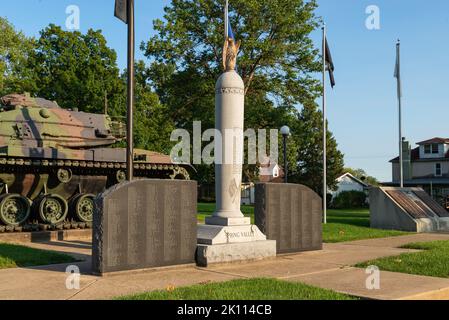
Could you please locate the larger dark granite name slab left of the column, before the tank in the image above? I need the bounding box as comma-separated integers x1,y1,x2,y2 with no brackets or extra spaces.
92,180,197,274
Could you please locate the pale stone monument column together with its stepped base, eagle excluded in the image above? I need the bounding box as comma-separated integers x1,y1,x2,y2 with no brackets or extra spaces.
197,71,276,266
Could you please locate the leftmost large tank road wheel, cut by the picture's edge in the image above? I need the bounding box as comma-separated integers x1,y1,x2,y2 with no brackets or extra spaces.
0,194,31,227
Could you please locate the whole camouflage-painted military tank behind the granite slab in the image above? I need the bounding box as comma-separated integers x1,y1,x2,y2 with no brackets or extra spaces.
0,94,189,232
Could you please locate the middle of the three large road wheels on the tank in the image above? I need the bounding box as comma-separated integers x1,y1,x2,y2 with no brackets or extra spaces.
38,194,68,225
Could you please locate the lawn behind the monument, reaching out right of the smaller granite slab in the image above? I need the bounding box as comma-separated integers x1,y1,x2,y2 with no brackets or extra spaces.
198,203,408,243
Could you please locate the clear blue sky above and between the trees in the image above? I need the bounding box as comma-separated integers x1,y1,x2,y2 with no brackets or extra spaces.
0,0,449,181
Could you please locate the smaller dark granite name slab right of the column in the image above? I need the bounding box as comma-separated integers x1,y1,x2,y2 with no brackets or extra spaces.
255,183,323,253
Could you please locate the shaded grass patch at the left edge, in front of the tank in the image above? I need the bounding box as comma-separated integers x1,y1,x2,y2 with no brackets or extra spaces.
0,243,77,269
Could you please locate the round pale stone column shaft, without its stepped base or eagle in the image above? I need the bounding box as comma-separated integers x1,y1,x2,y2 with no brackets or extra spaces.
206,70,251,226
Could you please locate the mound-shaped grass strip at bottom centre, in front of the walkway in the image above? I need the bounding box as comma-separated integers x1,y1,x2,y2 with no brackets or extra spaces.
119,279,356,300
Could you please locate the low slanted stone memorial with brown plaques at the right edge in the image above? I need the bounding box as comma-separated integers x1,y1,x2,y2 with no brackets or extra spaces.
369,187,449,232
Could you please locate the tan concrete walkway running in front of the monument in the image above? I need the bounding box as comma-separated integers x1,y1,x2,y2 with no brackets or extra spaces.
0,234,449,300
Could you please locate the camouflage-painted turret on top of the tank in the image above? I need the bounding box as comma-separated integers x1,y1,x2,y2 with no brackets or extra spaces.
0,94,125,148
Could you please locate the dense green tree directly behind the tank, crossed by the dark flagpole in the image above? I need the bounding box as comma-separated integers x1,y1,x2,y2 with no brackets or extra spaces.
30,25,173,153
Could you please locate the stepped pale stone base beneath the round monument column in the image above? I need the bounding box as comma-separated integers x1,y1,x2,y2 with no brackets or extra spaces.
196,224,276,267
